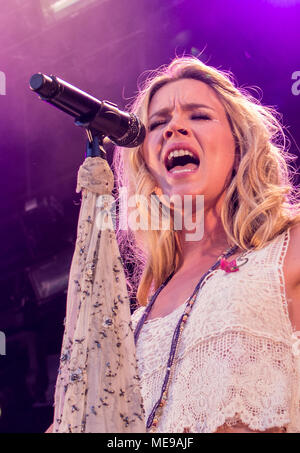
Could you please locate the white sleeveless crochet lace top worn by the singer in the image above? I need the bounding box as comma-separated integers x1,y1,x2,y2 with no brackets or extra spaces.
132,230,300,433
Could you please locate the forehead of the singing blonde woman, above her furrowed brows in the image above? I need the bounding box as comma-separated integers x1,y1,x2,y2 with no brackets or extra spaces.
148,79,224,116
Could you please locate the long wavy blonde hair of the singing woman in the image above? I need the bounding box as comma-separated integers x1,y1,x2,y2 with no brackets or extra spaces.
112,56,300,305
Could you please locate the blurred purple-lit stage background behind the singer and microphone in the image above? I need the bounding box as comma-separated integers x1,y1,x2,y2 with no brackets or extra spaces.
0,0,300,433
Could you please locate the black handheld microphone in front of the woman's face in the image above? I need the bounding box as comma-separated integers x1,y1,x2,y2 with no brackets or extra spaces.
29,72,146,148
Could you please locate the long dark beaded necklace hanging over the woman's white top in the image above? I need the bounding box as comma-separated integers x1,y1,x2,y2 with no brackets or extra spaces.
134,245,238,432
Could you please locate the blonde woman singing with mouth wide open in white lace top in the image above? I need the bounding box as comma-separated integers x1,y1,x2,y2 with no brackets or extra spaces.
114,57,300,433
